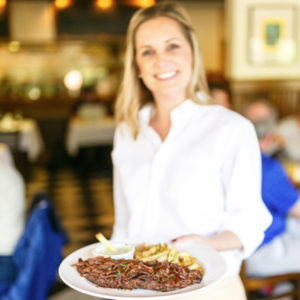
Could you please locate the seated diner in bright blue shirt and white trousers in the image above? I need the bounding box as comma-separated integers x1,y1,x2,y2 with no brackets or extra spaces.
243,99,300,276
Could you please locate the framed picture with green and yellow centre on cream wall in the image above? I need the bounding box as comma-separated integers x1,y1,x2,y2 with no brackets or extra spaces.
247,3,300,66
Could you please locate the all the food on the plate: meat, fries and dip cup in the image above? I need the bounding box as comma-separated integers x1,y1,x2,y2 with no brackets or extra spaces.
74,233,204,292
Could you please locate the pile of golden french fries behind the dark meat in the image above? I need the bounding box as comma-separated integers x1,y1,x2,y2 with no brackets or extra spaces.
134,243,204,273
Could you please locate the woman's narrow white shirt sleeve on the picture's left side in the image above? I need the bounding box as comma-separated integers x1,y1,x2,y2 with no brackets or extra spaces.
111,129,129,241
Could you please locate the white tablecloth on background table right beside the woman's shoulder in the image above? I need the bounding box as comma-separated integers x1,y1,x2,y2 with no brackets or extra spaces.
66,117,115,156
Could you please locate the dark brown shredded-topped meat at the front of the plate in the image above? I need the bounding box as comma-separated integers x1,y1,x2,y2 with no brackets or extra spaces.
74,256,203,292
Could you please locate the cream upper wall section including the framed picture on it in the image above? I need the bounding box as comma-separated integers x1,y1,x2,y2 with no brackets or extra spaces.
225,0,300,81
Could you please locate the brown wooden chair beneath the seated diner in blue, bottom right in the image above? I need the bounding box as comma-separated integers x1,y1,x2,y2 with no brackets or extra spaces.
240,263,300,300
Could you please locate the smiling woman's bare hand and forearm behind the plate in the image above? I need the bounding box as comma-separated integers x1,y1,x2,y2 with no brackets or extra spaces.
171,231,243,251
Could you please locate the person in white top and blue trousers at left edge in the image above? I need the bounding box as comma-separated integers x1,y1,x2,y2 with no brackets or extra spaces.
0,161,25,285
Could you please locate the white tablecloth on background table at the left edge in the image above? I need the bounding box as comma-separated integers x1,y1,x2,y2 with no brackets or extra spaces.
0,118,44,161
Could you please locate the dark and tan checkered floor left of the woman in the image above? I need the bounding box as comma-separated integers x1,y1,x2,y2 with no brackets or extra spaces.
26,167,113,256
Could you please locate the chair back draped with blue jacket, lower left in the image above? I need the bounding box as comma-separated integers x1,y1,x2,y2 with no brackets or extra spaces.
0,194,66,300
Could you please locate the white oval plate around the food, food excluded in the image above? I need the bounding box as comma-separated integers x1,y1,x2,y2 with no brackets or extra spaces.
59,243,227,300
